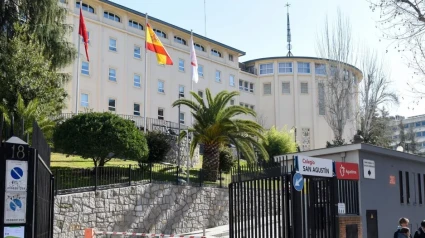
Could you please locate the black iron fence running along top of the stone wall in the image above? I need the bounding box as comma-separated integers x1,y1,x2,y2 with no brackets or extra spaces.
52,163,231,194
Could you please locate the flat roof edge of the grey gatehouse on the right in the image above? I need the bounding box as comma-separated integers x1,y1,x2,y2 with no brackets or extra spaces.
274,143,425,162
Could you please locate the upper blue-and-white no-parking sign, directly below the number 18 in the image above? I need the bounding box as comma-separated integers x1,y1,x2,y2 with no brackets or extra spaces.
6,160,28,192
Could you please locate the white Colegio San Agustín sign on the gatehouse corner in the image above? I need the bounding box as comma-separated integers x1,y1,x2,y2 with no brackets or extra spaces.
297,155,333,177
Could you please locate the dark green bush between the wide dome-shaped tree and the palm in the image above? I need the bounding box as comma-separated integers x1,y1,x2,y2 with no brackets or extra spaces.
146,131,173,163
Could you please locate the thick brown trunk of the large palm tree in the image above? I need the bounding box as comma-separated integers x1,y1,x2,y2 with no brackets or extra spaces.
202,144,220,182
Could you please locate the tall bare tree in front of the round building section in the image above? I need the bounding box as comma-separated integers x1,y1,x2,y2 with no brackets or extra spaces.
317,9,356,144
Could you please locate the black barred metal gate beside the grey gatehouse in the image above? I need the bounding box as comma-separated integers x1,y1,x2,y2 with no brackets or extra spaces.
229,159,338,238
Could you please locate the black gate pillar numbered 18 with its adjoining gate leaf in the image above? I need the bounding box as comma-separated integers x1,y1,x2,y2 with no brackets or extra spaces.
0,124,54,238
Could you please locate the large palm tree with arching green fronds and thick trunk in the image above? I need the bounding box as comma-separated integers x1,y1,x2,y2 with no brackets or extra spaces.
173,89,268,181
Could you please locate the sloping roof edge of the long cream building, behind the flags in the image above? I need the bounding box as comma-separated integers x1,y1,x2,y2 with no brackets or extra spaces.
99,0,246,56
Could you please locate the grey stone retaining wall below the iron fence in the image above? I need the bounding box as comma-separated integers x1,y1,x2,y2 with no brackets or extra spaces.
54,184,229,238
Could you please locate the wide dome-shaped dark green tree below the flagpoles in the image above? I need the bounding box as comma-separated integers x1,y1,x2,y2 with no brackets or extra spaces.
53,112,149,167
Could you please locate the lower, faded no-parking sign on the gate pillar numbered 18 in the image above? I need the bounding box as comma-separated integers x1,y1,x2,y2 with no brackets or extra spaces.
4,192,27,224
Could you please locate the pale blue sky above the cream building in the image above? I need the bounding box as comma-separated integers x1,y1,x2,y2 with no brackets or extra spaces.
113,0,425,117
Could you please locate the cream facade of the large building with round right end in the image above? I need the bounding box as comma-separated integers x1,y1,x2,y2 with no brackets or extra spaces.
60,0,362,150
